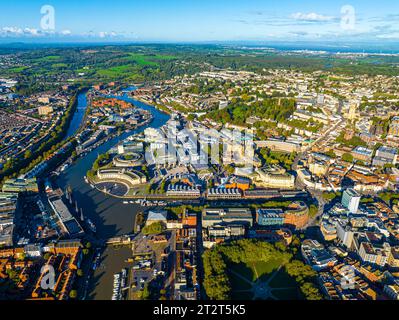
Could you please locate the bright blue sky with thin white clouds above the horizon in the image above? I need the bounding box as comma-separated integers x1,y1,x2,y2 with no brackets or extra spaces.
0,0,399,42
